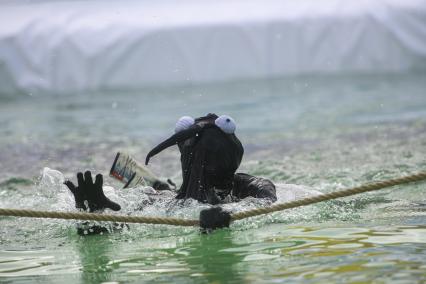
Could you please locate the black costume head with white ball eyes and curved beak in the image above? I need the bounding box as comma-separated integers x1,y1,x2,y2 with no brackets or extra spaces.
145,114,244,203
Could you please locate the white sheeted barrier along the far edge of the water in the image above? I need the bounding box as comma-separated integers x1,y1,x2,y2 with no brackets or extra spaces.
0,0,426,94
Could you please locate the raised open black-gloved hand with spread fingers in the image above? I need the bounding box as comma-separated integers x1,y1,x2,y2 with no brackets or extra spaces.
64,171,121,212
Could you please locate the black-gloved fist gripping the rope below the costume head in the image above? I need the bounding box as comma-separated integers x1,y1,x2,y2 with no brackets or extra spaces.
200,207,231,232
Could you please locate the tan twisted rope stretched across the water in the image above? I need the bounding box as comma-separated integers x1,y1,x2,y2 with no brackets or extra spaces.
0,172,426,226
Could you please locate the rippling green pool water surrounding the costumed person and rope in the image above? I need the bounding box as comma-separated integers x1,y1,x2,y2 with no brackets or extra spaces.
0,73,426,283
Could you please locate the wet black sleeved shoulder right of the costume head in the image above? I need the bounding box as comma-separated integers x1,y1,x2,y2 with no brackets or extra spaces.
232,173,277,202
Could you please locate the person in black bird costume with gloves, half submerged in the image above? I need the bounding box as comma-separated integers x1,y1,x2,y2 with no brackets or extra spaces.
65,114,277,229
